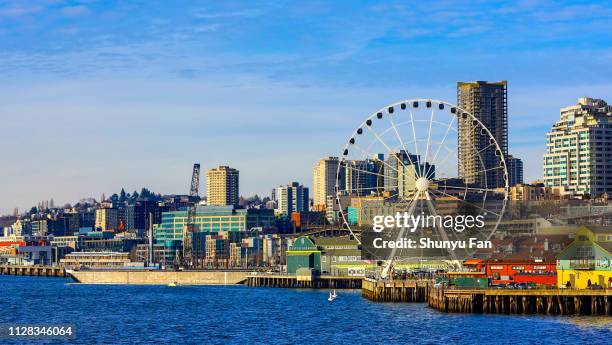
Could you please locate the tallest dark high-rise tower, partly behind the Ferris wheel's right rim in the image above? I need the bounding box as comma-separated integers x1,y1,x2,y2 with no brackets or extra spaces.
457,80,508,188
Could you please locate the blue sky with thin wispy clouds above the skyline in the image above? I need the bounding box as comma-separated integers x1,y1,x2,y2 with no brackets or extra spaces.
0,0,612,213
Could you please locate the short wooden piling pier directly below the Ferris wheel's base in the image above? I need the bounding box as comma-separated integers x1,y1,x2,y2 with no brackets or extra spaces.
361,278,433,303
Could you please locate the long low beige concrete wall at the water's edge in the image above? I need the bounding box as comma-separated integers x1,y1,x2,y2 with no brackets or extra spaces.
66,270,250,285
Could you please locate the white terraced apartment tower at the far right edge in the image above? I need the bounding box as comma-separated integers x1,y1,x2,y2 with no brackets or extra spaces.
544,98,612,196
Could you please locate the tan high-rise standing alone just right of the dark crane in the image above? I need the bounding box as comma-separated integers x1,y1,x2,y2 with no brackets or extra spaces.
206,166,239,206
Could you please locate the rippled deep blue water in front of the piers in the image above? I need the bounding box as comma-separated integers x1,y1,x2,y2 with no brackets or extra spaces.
0,276,612,344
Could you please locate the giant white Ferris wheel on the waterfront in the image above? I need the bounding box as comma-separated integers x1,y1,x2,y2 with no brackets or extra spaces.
335,99,508,268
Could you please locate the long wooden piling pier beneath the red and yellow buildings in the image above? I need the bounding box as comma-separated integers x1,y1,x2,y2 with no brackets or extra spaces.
427,287,612,315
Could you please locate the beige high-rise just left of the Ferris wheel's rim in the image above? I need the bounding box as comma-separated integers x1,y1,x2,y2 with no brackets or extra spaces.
312,157,345,211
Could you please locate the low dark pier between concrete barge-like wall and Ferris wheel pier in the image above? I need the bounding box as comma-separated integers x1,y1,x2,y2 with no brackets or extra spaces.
246,273,362,289
